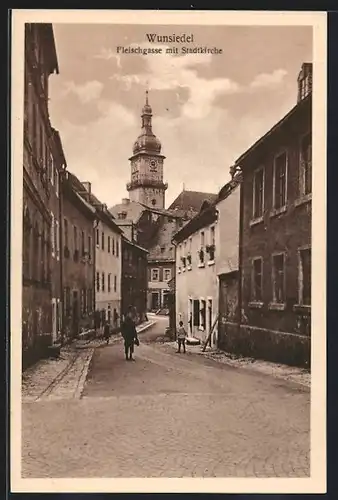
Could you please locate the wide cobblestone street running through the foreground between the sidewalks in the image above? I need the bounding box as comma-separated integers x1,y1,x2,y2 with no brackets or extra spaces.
22,320,310,478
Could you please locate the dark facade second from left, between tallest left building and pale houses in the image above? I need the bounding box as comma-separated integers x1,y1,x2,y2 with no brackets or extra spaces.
61,171,96,340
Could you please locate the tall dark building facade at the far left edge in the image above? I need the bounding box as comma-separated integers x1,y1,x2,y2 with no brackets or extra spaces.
22,23,58,367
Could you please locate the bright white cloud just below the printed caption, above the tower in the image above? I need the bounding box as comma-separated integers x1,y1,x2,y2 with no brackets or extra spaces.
111,43,240,119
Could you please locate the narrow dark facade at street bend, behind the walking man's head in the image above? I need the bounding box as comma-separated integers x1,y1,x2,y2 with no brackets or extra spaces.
121,238,147,323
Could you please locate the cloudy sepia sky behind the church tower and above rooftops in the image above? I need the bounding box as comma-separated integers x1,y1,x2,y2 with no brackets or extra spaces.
50,24,312,206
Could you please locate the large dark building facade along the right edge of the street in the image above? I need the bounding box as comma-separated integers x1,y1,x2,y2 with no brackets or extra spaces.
236,64,312,366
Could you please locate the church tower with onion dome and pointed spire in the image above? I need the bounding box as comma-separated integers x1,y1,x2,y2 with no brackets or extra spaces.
127,91,168,208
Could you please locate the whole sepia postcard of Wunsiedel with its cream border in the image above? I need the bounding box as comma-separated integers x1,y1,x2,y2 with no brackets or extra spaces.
10,10,326,493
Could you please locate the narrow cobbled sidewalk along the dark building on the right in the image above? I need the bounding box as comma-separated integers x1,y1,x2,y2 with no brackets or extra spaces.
166,342,311,388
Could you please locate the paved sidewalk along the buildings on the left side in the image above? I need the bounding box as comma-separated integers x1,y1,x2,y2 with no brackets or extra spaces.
22,320,155,403
